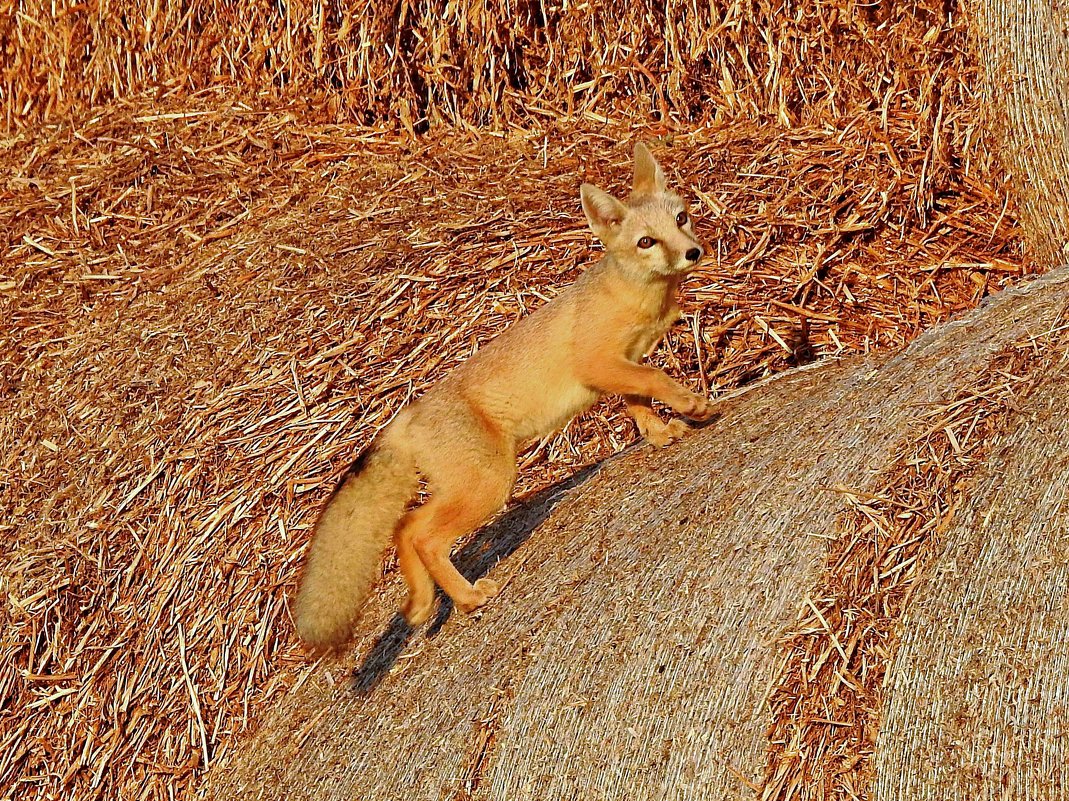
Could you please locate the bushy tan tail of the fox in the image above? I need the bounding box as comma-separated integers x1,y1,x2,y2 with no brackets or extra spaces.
293,437,419,648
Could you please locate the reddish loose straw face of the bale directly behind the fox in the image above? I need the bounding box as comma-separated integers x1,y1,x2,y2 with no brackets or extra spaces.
0,97,1023,798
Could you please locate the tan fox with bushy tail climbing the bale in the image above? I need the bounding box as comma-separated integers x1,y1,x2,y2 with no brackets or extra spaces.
293,142,712,650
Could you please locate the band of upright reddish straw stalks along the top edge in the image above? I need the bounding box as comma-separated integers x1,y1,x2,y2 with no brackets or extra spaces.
0,0,967,130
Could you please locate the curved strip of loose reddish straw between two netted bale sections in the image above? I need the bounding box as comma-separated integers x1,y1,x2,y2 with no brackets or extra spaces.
760,320,1067,799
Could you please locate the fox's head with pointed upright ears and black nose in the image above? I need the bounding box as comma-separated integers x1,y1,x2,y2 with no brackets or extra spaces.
579,142,704,277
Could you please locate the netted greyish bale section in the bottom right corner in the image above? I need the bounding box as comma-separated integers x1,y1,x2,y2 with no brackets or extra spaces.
872,363,1069,801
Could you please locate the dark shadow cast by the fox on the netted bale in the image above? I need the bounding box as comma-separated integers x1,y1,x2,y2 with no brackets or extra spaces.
353,464,601,694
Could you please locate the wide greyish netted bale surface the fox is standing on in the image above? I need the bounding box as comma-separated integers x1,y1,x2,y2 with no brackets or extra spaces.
208,268,1069,799
